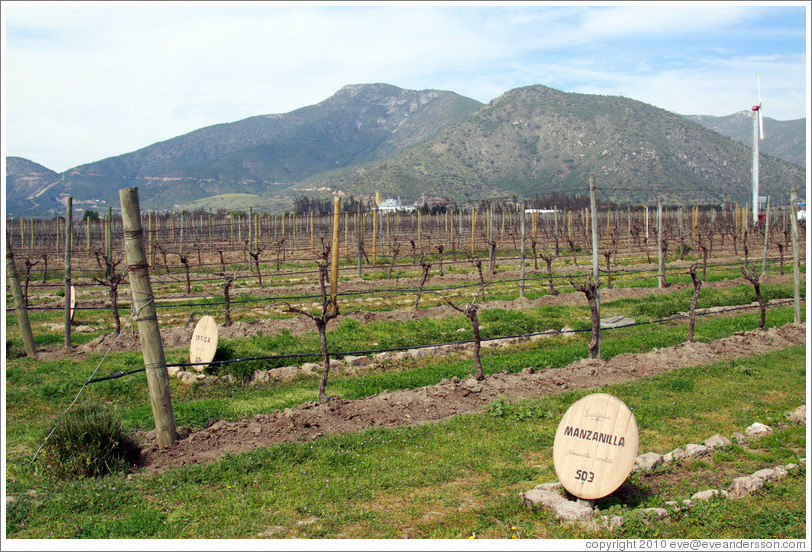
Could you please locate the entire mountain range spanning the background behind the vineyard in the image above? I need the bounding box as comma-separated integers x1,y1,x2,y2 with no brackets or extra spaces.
7,84,805,216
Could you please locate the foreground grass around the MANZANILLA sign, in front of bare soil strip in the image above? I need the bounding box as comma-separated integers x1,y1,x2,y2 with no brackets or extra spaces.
7,346,806,538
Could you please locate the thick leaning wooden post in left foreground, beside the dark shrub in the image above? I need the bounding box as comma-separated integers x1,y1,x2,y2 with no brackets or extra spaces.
119,188,177,447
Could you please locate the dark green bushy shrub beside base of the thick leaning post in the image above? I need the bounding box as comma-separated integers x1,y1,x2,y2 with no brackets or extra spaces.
40,405,140,478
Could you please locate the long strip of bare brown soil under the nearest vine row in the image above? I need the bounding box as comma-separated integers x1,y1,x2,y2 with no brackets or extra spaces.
142,324,806,472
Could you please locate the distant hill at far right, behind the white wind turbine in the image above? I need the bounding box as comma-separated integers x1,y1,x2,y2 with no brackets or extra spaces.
686,111,806,168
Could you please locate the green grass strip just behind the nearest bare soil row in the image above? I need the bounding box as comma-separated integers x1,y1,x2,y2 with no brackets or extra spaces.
6,286,804,440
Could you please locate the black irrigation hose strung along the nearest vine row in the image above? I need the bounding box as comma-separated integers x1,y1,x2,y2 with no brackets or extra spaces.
85,298,806,385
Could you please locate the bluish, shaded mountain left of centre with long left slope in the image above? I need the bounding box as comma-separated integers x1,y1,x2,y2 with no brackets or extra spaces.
23,84,482,216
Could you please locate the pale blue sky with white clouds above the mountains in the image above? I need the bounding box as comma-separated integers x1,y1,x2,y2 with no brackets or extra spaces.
2,1,810,172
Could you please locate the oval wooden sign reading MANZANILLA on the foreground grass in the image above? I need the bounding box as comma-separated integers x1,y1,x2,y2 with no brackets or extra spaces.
553,393,639,500
